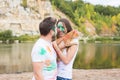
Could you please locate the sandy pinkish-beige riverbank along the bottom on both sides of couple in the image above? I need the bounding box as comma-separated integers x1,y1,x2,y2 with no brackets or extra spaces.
0,69,120,80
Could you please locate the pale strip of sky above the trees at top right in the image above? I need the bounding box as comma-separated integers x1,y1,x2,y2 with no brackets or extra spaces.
83,0,120,7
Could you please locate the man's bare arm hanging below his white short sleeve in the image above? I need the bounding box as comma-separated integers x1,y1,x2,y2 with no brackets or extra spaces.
32,62,44,80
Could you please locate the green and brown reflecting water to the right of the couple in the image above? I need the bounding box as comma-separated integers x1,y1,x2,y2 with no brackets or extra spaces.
74,43,120,69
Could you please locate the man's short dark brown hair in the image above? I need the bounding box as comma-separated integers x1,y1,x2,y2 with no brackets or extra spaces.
39,17,57,36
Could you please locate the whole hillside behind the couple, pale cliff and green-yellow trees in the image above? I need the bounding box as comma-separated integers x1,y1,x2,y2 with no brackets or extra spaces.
0,0,120,36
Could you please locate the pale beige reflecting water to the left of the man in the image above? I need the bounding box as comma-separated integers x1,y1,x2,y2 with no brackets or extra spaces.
0,43,33,73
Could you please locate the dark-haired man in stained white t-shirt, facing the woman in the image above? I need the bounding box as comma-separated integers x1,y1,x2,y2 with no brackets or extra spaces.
31,17,57,80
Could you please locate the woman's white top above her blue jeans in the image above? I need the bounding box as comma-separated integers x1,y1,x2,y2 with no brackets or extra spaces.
57,39,79,79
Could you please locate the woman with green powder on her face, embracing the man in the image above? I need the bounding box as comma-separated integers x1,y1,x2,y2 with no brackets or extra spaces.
53,18,79,80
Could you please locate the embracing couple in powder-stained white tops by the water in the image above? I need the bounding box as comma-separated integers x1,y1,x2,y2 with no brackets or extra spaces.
31,17,79,80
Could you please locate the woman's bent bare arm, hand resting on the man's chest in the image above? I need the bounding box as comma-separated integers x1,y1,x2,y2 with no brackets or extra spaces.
53,42,78,64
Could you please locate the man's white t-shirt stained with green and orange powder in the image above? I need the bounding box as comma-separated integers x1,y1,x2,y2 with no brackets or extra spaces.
31,38,57,80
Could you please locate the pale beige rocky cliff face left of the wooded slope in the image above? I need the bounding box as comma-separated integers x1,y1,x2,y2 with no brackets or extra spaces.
0,0,54,36
